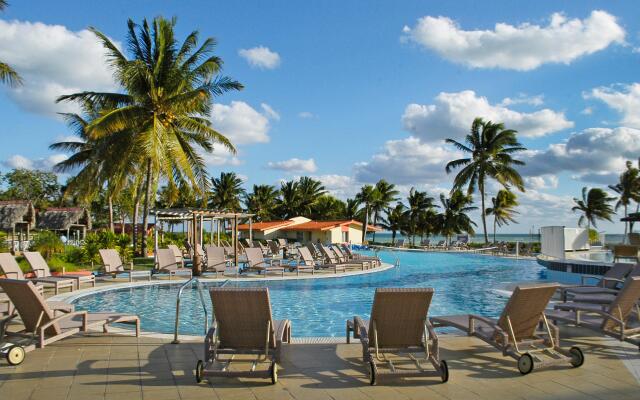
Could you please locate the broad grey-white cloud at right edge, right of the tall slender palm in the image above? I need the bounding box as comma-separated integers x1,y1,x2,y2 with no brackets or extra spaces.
520,127,640,183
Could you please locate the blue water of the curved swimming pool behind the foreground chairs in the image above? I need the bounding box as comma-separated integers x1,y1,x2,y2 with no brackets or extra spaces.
74,252,544,337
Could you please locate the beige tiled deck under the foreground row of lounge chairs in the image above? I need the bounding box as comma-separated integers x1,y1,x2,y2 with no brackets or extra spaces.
0,328,640,400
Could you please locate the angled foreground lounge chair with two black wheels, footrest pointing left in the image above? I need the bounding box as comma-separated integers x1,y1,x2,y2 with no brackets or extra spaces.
431,284,584,375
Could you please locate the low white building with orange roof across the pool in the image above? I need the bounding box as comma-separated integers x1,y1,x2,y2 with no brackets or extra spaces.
238,217,381,244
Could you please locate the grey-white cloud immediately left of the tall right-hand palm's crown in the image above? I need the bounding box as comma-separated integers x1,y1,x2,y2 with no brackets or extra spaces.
354,136,462,185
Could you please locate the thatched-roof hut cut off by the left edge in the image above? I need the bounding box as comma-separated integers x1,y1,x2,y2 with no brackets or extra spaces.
0,200,36,251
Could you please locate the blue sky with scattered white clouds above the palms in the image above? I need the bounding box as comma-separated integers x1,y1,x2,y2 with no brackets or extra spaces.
0,0,640,233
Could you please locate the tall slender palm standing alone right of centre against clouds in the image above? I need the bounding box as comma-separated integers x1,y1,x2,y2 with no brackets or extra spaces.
446,118,526,243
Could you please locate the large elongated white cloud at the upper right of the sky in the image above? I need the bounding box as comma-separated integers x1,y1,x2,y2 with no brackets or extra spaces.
403,10,625,71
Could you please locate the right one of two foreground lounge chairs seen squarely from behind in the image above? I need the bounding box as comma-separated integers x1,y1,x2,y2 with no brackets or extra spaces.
347,288,449,385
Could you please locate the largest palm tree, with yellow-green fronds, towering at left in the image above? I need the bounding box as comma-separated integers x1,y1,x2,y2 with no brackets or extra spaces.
58,17,242,252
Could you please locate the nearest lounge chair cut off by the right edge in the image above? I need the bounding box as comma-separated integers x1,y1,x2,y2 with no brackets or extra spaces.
545,276,640,350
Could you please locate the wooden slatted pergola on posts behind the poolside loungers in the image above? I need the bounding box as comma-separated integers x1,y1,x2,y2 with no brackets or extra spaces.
150,208,255,275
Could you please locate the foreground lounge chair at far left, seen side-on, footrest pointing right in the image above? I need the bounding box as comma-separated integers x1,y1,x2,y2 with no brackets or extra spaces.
0,279,140,347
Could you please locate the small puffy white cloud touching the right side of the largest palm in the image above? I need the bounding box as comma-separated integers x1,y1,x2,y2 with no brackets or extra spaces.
211,101,270,146
